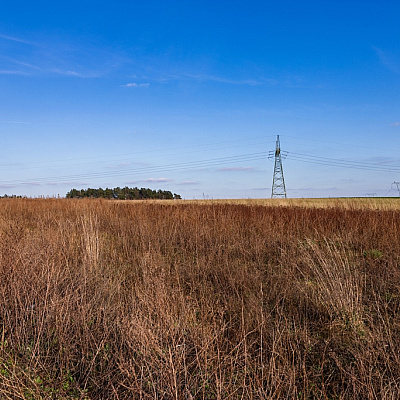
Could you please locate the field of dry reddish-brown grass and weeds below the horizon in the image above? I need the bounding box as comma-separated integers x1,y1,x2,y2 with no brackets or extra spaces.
0,199,400,400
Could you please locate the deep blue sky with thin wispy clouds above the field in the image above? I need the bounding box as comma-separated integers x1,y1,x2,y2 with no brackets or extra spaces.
0,0,400,199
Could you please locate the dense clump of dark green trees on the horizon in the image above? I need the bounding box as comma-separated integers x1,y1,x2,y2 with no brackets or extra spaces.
65,187,181,200
